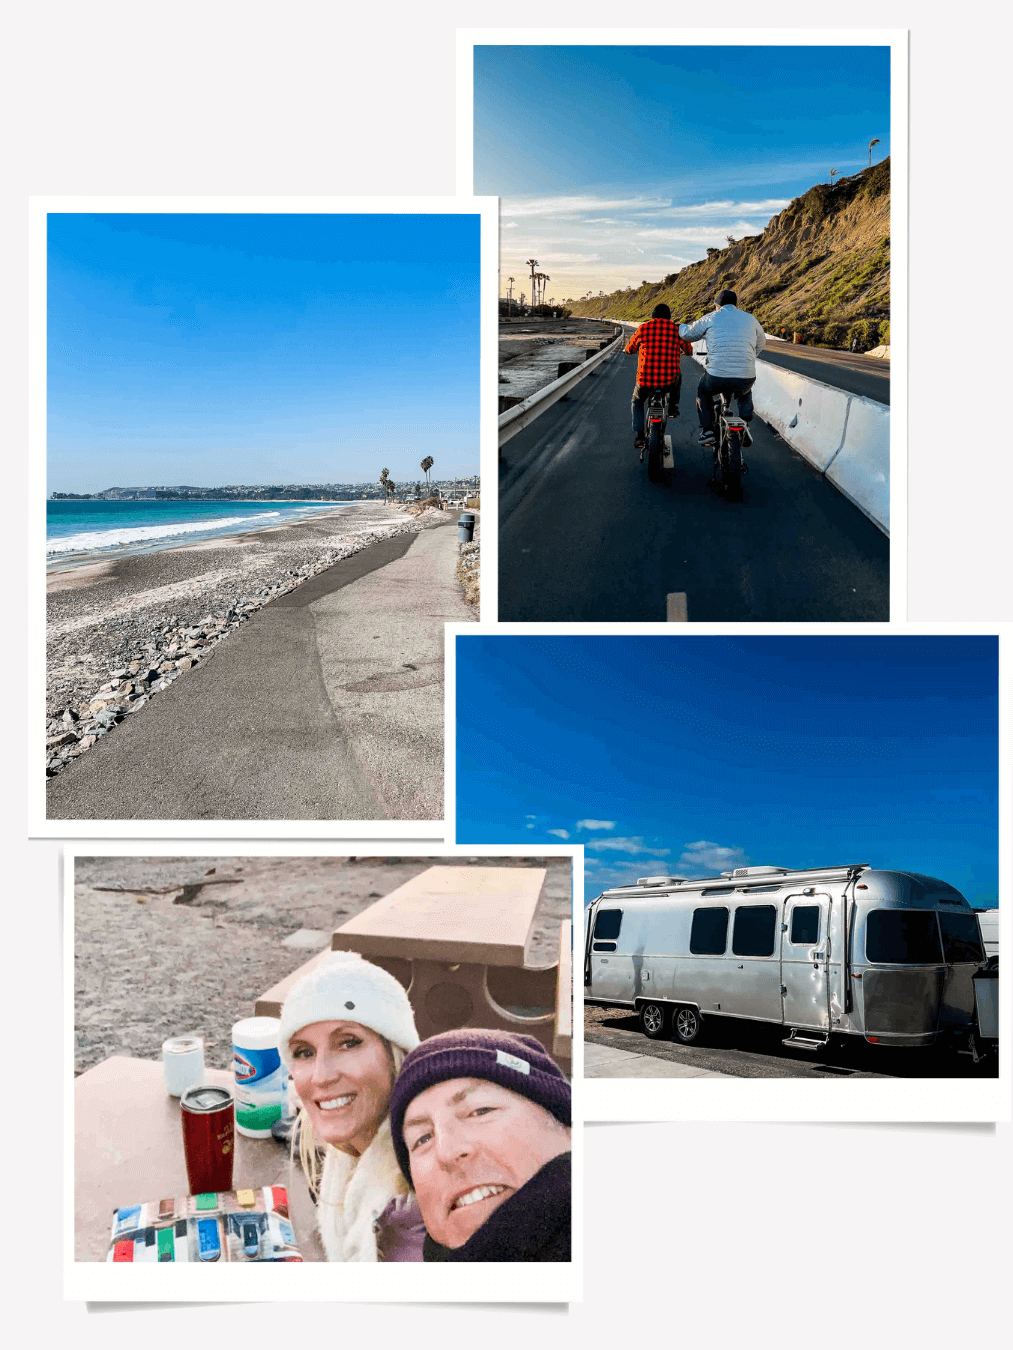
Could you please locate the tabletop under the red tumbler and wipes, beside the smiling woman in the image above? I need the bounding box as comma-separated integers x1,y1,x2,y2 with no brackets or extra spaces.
74,1054,326,1263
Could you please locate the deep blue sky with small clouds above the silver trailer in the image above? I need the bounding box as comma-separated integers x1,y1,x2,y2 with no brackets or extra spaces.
457,635,998,905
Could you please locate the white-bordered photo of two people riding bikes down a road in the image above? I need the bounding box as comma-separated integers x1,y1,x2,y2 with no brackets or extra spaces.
458,28,906,622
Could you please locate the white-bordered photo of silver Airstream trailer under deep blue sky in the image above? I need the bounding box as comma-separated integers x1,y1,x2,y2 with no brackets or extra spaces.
447,625,1010,1121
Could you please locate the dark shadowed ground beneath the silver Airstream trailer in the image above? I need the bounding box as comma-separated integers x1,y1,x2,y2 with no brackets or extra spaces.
583,1007,998,1079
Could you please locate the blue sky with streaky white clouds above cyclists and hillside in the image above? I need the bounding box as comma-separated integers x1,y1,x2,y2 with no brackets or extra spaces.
474,46,890,301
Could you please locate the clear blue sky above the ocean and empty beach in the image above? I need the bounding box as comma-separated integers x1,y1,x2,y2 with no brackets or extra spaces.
49,213,479,491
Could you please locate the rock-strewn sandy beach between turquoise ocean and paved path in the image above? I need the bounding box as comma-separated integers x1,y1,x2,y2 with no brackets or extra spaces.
46,501,447,776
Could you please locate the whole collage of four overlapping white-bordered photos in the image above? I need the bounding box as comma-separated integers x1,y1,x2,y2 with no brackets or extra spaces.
8,20,1013,1350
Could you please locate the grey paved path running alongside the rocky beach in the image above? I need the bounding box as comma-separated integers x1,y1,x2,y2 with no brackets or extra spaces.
46,514,477,821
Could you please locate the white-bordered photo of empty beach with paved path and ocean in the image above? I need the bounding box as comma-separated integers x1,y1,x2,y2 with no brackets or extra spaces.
38,198,489,837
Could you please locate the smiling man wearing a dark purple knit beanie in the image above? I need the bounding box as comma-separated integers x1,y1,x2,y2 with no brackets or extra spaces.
390,1029,570,1261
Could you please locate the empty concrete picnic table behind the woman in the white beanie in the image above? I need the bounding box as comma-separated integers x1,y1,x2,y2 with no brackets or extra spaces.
255,865,559,1054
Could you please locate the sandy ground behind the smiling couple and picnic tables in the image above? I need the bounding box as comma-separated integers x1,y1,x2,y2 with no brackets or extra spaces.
74,856,571,1073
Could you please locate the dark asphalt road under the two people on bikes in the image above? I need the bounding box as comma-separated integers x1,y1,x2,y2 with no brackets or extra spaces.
498,352,890,621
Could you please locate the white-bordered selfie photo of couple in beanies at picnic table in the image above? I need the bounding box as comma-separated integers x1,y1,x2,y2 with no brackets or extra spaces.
66,844,579,1301
